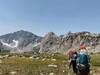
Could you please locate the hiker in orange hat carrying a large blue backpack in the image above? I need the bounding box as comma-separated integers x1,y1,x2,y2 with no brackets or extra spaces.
77,45,90,75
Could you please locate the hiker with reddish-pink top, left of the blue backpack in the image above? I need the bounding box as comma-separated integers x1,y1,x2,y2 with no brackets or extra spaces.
67,48,77,73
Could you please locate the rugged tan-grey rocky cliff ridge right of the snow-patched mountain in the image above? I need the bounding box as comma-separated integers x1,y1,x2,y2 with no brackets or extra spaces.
40,32,100,53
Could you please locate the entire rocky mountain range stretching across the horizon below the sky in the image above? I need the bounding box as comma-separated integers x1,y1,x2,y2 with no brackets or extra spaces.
0,30,100,53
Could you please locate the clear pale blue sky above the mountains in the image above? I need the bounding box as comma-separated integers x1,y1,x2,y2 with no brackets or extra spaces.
0,0,100,36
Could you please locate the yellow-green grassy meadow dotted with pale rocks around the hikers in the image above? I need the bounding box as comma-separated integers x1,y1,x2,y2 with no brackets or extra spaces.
0,54,100,75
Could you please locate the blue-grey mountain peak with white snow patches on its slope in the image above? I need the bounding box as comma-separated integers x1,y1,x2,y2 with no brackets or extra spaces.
0,30,41,52
